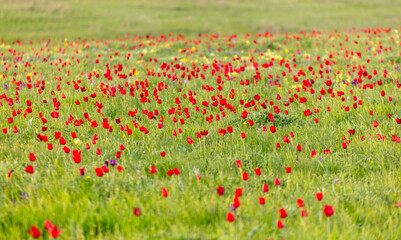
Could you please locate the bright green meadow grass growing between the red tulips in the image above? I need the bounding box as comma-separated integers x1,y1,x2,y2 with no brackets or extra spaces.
0,30,401,239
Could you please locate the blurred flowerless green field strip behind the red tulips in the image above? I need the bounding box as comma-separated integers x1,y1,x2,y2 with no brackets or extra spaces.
0,0,401,41
